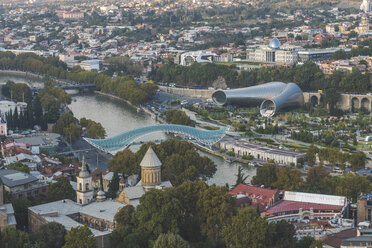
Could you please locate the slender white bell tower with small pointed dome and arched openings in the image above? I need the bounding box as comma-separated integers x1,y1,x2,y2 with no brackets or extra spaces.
76,154,93,205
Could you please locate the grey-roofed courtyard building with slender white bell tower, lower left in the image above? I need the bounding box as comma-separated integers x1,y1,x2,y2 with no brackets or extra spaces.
28,155,125,248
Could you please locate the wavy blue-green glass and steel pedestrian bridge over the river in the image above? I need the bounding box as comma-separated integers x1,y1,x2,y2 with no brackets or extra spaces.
84,124,228,152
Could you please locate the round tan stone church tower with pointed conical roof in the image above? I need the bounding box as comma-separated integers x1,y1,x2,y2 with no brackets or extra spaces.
140,147,161,191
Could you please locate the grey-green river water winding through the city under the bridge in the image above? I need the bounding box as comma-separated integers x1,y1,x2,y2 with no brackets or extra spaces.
0,73,256,186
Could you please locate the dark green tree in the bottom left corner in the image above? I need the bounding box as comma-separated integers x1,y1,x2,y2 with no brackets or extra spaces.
0,227,29,248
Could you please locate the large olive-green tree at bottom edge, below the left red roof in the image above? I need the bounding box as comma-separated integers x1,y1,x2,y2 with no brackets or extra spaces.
222,208,271,248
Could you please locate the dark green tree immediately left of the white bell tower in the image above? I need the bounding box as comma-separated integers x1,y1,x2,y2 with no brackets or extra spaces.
47,177,76,201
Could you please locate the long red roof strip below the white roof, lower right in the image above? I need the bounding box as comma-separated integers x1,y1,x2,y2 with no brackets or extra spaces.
266,200,343,214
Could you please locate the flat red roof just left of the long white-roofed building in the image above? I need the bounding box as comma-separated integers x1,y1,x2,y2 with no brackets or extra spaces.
229,184,279,205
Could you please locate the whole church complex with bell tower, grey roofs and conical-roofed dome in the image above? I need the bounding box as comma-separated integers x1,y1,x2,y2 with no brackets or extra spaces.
29,147,172,247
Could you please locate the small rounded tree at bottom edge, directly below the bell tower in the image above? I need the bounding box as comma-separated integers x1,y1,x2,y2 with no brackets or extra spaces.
63,226,97,248
